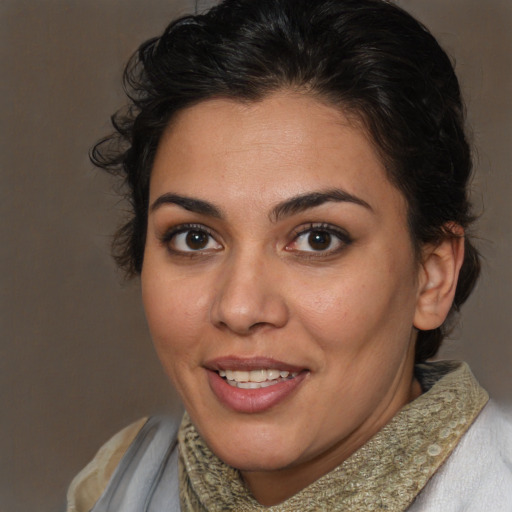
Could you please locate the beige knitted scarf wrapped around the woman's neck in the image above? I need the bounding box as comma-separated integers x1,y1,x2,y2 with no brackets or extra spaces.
178,361,488,512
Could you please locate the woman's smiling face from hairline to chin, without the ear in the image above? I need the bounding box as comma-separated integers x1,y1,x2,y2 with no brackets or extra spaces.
142,92,421,479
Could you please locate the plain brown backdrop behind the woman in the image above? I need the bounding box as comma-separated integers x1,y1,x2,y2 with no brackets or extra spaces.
0,0,512,512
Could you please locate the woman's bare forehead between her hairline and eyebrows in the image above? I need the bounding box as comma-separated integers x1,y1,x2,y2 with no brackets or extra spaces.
150,92,404,218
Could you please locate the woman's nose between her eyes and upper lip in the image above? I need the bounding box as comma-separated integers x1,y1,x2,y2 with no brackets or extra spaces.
210,254,289,336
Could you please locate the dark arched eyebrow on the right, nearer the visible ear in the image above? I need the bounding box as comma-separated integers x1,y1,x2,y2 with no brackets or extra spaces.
270,188,373,222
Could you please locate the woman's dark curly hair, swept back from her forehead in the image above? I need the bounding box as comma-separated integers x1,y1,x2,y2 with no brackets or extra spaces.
91,0,480,361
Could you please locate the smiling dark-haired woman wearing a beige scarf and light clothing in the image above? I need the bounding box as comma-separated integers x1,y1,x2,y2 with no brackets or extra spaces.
69,0,512,512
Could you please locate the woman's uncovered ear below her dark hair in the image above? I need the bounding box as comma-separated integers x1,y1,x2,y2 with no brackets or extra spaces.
414,225,464,331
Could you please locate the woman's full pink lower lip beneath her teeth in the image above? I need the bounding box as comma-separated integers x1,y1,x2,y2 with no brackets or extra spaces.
207,370,308,413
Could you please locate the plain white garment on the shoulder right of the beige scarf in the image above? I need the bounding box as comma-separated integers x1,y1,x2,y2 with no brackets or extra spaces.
410,401,512,512
